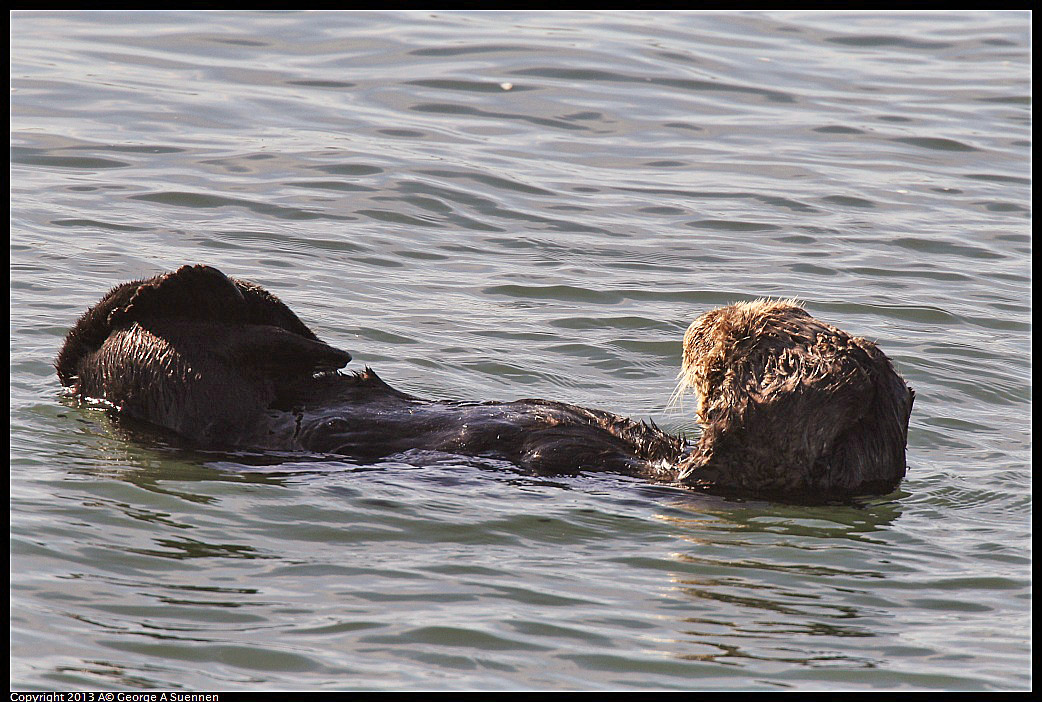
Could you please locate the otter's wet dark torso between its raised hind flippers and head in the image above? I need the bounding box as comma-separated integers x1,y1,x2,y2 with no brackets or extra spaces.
277,368,685,474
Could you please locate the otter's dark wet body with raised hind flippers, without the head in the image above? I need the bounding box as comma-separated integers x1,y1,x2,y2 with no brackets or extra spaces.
55,266,684,473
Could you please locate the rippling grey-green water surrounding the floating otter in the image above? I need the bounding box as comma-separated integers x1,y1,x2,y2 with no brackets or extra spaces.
10,11,1032,691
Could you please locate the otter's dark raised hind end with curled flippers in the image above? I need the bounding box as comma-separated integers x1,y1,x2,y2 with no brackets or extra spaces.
54,266,351,446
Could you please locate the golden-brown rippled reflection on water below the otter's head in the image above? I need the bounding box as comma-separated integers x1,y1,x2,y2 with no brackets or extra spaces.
656,491,901,668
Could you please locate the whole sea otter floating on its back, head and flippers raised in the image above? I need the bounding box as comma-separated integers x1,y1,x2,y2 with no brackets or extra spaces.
60,266,914,501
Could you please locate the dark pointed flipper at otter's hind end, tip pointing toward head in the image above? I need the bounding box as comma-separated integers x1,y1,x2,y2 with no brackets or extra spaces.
219,324,351,377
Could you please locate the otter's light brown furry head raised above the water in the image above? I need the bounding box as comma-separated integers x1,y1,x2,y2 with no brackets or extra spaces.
677,300,915,497
